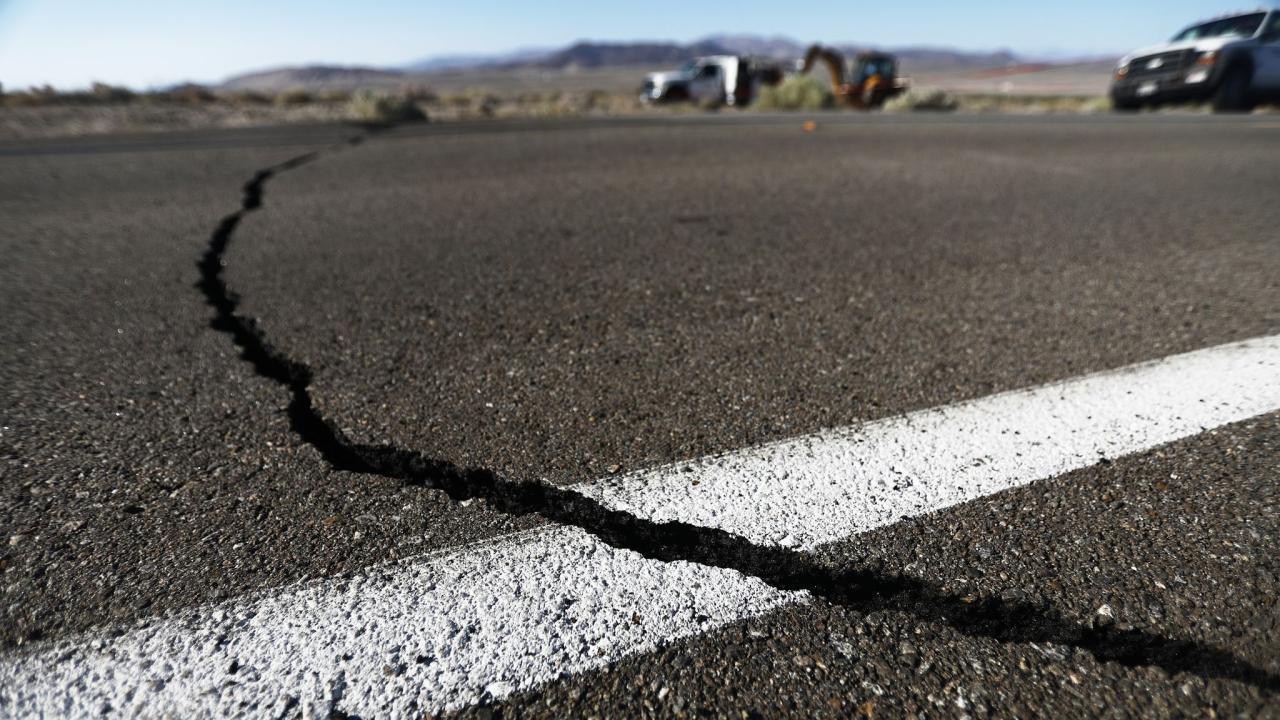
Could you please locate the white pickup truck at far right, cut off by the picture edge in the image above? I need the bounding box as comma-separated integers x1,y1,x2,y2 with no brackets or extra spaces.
1111,10,1280,113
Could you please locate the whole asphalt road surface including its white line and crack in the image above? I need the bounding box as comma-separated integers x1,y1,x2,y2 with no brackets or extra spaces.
0,114,1280,717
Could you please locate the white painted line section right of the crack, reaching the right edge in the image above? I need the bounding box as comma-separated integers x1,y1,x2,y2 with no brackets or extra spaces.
581,336,1280,548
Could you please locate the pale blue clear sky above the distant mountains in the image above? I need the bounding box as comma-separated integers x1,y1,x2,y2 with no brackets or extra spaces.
0,0,1269,88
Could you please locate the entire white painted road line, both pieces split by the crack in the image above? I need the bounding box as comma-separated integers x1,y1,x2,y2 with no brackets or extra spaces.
0,337,1280,717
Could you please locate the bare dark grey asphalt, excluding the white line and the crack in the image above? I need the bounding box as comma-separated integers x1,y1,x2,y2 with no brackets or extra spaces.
0,115,1280,717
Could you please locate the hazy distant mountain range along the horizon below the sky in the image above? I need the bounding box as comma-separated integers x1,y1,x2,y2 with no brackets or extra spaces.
221,35,1100,91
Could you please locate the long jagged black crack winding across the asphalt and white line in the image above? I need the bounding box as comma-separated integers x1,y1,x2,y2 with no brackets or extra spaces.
197,131,1280,693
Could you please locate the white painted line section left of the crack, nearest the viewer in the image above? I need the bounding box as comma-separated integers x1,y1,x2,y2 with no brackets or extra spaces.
0,528,803,719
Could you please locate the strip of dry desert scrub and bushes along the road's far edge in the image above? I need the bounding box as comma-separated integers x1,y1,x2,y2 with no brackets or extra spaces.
0,76,1277,138
